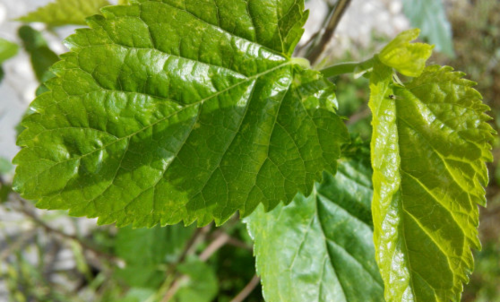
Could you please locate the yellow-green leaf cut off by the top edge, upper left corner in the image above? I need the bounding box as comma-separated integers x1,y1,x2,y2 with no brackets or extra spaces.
17,0,109,26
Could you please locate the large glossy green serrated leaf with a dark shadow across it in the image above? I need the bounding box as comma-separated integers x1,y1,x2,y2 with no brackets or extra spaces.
14,0,347,226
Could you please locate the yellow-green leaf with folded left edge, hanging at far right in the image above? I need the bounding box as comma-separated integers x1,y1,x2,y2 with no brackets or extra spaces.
369,55,493,302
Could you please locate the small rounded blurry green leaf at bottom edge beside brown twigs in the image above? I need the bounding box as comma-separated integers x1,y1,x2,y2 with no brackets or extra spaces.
172,260,219,302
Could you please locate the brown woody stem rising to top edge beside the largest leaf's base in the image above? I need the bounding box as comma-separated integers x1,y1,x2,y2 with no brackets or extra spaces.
307,0,351,65
